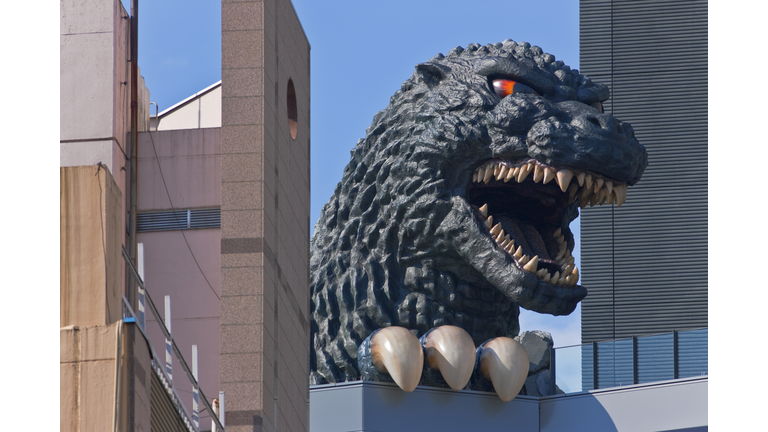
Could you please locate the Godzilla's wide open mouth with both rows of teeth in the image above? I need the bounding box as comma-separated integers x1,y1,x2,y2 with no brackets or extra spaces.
467,158,627,286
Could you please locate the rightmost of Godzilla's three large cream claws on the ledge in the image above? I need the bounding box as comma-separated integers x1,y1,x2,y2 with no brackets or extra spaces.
478,337,530,402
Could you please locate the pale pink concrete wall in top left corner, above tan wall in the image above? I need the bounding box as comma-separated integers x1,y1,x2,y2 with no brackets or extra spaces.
59,0,149,195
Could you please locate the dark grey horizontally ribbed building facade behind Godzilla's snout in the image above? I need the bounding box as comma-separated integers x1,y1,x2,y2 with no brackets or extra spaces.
579,0,707,343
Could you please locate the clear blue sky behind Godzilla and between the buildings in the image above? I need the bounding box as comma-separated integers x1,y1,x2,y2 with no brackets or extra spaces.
136,0,581,346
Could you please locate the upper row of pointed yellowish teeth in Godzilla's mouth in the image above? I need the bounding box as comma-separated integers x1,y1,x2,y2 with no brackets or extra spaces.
472,159,627,208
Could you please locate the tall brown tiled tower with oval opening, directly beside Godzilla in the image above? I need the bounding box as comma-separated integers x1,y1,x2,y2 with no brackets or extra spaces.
221,0,310,432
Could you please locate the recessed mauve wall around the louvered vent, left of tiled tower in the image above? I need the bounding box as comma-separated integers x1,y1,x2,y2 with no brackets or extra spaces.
138,128,221,416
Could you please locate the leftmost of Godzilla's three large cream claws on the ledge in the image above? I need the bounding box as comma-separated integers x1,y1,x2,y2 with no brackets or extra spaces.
371,326,424,393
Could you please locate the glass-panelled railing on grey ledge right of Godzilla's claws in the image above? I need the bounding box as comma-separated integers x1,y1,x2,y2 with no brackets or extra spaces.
554,328,708,393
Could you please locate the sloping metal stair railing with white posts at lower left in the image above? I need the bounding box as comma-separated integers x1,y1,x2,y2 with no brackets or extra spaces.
123,247,224,432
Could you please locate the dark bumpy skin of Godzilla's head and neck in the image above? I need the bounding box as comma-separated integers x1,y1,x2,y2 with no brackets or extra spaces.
310,40,647,385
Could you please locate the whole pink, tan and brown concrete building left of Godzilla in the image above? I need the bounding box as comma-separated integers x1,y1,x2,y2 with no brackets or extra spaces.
60,0,310,431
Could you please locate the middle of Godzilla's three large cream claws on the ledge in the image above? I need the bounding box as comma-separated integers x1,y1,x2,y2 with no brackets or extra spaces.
424,325,475,390
